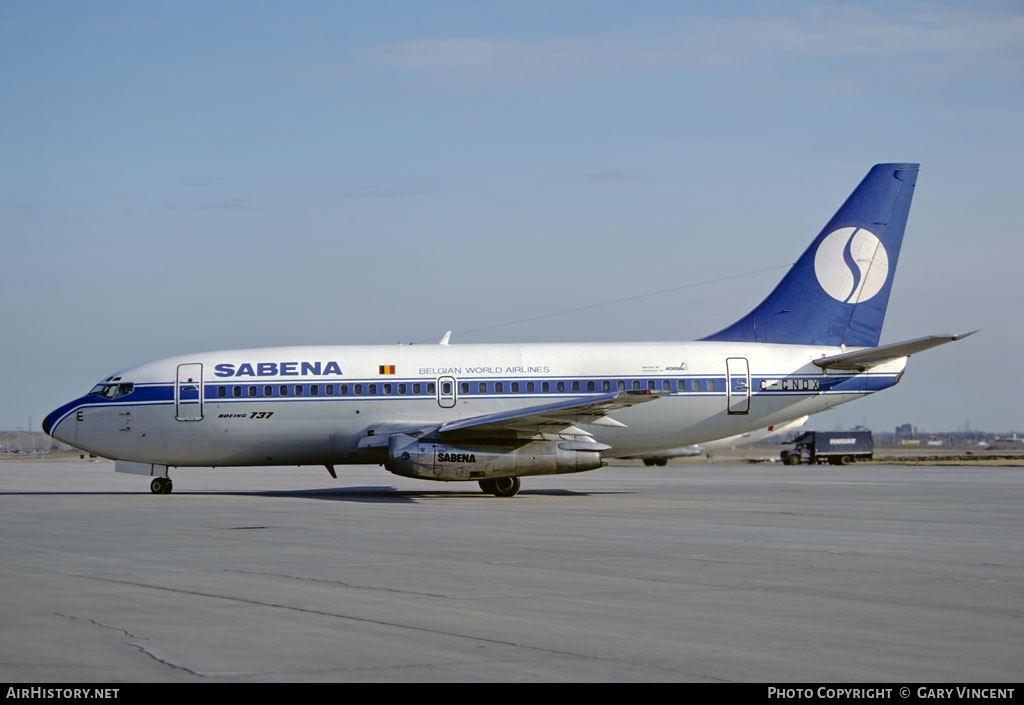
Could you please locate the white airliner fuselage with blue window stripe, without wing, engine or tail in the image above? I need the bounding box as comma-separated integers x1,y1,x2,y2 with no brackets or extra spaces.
48,341,906,466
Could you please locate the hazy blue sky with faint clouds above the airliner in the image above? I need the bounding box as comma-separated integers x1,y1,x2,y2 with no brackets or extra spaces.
0,0,1024,430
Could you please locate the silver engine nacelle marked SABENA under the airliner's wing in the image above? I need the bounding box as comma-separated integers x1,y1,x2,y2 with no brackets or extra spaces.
384,436,610,480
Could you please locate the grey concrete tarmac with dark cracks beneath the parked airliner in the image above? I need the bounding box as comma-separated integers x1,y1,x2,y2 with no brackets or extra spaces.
0,461,1024,683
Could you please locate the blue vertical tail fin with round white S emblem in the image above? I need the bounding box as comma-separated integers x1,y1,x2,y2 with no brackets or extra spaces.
703,164,918,347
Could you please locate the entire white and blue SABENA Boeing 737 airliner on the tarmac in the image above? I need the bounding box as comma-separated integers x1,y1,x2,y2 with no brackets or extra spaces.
43,164,964,497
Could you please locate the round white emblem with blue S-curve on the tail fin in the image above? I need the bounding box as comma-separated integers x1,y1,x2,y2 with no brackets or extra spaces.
814,227,889,303
